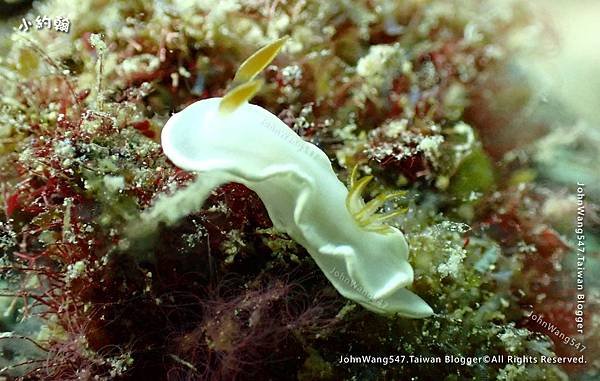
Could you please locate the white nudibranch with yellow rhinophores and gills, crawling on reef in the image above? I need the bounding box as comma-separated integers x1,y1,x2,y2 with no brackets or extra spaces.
161,38,433,318
